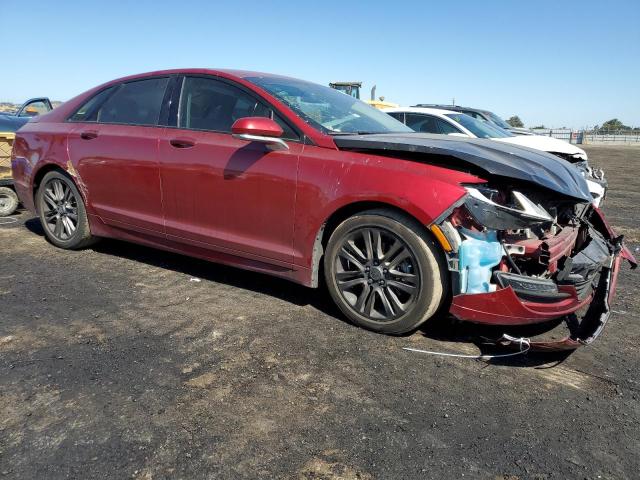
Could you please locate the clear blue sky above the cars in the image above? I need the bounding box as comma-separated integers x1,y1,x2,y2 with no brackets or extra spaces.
0,0,640,128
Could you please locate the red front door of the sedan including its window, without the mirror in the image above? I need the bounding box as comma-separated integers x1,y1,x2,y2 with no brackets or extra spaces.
160,76,303,264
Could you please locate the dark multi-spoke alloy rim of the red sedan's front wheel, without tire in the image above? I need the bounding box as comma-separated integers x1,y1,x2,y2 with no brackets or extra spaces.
334,227,420,322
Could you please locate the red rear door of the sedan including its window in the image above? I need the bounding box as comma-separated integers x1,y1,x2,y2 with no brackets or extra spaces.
69,77,170,234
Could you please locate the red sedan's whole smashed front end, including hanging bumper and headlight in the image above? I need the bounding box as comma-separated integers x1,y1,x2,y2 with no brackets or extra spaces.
431,184,636,350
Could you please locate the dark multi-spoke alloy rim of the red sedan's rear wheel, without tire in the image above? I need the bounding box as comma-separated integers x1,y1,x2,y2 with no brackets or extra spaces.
42,178,78,241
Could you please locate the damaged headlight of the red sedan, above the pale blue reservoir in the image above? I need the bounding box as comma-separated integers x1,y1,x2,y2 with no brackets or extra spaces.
465,186,554,230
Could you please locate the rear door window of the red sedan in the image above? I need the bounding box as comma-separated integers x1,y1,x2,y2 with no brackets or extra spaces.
97,77,169,125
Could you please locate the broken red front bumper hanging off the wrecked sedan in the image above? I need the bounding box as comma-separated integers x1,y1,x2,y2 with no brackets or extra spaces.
450,209,637,350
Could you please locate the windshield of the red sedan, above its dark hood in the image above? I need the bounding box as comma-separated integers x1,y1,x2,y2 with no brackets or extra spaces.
245,77,413,135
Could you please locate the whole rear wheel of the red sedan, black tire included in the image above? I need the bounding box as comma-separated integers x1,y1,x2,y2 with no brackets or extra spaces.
36,170,97,250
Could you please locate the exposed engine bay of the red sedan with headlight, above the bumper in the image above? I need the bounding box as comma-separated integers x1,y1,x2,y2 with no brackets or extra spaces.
440,185,621,302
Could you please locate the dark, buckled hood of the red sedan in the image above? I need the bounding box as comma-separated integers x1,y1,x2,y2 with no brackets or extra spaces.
334,133,591,202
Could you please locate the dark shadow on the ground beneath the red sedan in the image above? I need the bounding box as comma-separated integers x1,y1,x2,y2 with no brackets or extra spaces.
24,218,572,367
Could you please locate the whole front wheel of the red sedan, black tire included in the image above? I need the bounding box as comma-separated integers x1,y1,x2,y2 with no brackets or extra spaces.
324,209,449,335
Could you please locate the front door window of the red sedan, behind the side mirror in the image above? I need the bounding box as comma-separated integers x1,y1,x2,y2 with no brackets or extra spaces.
178,77,299,140
